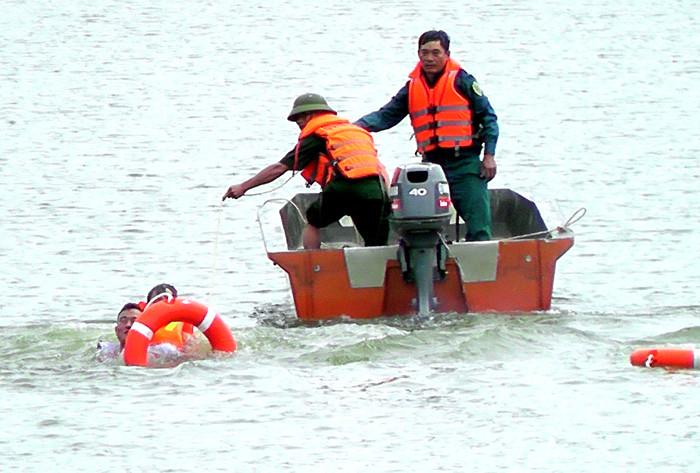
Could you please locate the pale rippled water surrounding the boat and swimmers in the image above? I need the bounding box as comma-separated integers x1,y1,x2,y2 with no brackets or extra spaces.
0,0,700,472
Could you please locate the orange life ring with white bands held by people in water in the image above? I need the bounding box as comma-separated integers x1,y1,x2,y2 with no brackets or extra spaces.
124,298,236,366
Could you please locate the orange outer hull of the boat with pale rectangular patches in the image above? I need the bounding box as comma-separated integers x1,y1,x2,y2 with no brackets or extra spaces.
268,235,574,320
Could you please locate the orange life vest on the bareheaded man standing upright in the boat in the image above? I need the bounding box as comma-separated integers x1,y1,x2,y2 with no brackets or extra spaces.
408,59,476,154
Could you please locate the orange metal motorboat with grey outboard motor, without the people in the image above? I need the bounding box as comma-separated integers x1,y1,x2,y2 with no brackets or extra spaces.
258,163,585,320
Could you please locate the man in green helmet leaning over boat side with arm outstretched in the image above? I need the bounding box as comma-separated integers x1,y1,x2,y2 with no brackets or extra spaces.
222,94,391,249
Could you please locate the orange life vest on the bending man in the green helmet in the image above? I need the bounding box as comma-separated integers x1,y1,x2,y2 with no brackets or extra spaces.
294,113,388,188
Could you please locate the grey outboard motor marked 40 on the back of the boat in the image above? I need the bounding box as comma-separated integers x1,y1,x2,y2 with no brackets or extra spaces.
389,163,451,316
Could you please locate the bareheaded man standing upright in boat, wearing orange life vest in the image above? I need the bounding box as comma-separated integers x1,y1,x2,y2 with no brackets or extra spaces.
355,30,498,241
